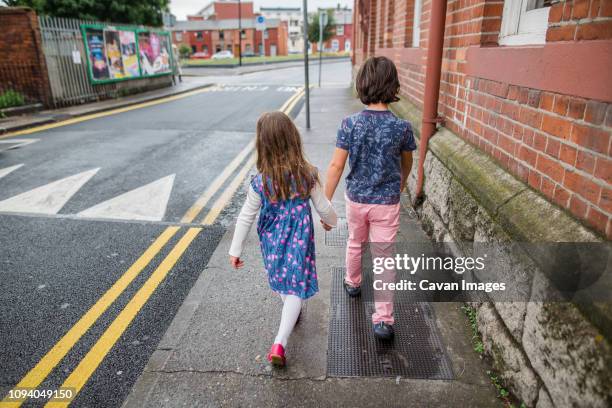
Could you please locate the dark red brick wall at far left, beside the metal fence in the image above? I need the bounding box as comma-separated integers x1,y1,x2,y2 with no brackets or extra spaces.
0,7,51,105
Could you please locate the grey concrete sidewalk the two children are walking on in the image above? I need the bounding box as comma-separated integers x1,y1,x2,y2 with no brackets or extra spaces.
124,88,502,407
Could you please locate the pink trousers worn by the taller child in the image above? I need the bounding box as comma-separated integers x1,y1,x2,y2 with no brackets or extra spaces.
345,198,400,324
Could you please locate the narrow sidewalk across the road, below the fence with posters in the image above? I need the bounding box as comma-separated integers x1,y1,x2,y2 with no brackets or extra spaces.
0,78,210,135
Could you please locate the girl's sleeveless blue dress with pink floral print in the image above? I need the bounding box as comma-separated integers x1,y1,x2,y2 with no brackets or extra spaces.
251,174,319,299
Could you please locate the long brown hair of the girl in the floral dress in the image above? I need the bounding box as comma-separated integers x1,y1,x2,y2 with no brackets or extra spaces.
255,112,318,201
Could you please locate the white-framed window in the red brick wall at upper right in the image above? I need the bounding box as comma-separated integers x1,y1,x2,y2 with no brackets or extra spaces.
499,0,552,45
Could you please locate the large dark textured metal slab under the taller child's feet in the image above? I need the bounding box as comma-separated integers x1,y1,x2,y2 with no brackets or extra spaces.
327,268,454,380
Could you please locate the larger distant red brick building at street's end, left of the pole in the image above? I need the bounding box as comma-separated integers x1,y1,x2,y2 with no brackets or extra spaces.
169,1,288,56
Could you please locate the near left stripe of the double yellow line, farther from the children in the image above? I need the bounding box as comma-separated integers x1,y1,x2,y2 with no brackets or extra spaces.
0,227,179,408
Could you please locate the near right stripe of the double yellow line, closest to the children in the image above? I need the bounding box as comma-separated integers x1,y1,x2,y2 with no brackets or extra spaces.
45,228,202,408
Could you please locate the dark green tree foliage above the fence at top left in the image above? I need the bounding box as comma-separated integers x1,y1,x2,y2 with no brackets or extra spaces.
0,0,170,26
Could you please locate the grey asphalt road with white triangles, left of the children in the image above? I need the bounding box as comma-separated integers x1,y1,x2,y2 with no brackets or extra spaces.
0,62,350,407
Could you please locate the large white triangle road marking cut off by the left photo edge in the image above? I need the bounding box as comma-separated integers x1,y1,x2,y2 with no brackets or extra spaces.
0,168,100,214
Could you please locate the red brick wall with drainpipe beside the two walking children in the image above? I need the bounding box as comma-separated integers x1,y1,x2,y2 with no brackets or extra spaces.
354,0,612,238
